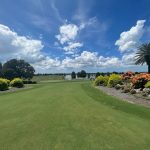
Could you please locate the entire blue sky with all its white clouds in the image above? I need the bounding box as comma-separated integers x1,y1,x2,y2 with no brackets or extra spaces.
0,0,150,73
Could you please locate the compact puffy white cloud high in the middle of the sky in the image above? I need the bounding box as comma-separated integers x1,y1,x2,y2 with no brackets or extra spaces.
56,24,79,44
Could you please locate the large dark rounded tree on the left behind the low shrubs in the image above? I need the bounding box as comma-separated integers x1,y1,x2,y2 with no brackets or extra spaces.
2,59,35,80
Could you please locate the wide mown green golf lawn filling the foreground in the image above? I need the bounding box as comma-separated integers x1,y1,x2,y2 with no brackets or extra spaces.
0,81,150,150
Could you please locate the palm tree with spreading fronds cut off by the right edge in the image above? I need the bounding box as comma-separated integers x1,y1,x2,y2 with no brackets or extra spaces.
135,43,150,73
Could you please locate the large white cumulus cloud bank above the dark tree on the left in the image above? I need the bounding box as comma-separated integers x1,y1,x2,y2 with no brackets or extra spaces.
0,24,60,68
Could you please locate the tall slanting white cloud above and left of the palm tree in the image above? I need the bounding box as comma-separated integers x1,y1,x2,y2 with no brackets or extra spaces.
115,20,146,52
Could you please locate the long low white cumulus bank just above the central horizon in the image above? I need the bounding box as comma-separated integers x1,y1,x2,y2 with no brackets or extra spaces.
62,51,120,68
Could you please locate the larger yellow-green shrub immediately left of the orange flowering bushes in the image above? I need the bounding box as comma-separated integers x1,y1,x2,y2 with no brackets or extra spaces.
107,74,122,87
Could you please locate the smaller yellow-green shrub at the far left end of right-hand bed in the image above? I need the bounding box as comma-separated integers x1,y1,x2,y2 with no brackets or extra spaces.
94,76,109,86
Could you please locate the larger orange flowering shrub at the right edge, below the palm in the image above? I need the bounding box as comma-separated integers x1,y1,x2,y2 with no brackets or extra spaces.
131,73,150,89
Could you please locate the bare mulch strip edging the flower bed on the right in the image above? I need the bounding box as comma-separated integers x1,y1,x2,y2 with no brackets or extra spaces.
99,86,150,107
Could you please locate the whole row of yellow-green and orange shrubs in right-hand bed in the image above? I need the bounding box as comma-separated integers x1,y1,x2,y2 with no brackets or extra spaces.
94,71,150,96
